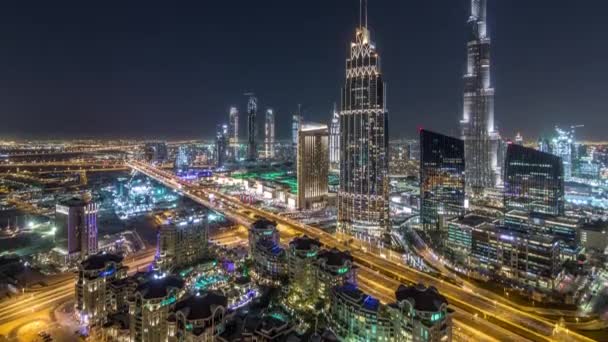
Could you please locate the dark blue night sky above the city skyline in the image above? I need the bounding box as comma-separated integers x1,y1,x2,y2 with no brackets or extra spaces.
0,0,608,140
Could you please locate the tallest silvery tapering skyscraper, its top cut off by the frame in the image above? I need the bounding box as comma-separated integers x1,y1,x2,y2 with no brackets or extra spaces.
460,0,501,194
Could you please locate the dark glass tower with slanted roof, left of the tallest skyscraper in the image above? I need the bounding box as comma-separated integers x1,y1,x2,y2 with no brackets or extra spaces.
420,130,466,232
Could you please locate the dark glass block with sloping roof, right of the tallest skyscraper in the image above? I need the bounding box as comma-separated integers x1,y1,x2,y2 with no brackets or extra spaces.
504,144,564,216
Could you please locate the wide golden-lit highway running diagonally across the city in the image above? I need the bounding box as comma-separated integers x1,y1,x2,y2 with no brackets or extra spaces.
128,161,592,341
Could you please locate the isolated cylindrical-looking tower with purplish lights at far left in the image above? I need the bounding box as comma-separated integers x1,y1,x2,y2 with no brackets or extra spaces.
55,198,97,259
